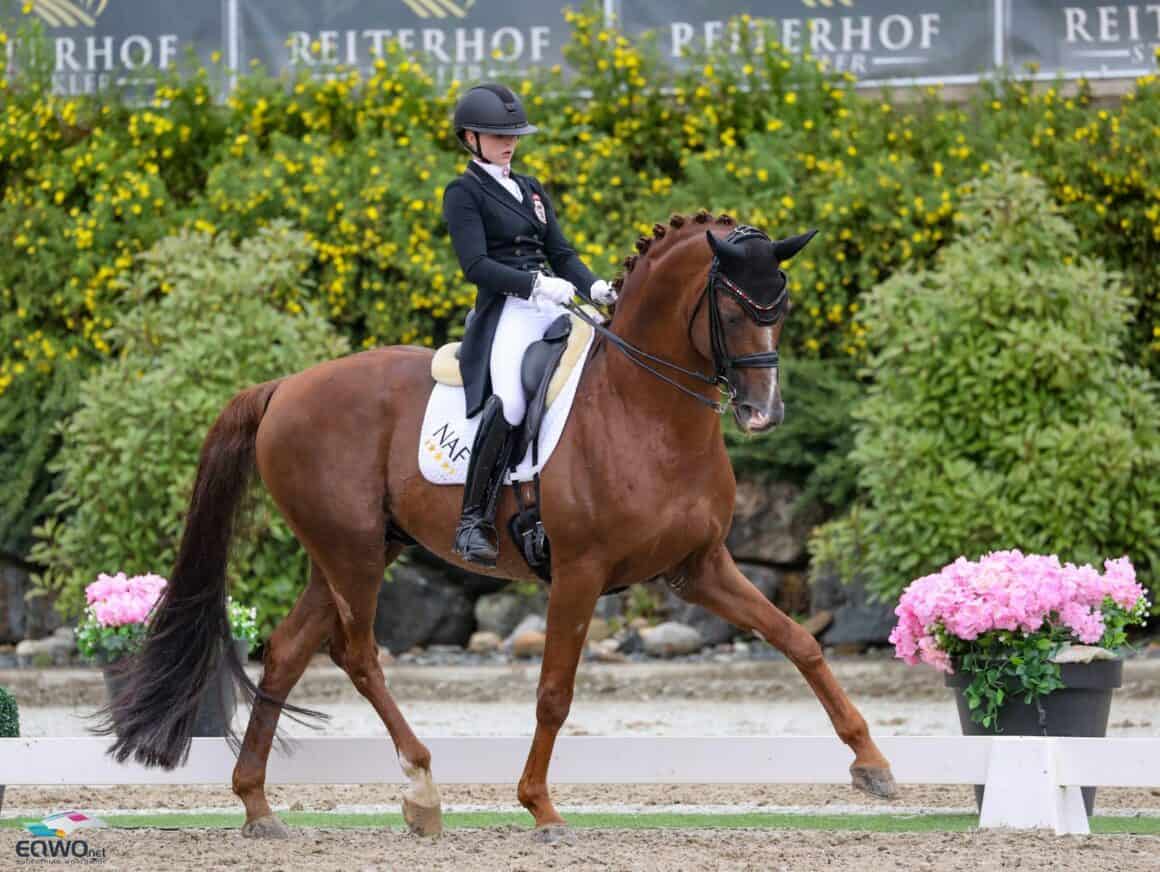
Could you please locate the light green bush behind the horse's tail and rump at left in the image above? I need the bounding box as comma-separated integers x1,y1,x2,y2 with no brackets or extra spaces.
31,226,347,632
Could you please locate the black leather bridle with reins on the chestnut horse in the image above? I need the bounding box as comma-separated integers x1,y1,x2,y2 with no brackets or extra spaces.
564,225,789,415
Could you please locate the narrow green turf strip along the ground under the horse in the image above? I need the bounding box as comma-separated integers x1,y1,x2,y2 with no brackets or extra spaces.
0,811,1160,835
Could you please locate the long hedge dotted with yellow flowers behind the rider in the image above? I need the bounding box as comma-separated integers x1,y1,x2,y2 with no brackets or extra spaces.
0,9,1160,551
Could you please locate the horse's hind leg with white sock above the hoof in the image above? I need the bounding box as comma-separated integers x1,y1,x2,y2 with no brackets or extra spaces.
326,538,443,836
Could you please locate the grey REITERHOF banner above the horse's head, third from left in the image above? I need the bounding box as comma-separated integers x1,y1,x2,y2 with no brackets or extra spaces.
618,0,1001,81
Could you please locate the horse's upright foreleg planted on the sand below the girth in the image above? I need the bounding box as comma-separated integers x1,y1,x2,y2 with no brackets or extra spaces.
519,568,603,827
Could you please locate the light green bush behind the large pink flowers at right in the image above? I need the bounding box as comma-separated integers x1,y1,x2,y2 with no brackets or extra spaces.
814,165,1160,600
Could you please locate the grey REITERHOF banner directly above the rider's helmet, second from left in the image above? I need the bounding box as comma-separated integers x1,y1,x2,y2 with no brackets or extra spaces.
240,0,579,83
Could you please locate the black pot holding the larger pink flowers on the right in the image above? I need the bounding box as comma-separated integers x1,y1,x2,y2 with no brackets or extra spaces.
947,660,1124,818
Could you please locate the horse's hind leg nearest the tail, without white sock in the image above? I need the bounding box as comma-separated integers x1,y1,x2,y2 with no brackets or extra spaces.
233,564,335,838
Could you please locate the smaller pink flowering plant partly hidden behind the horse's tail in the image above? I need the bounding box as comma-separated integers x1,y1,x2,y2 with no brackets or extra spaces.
77,573,258,663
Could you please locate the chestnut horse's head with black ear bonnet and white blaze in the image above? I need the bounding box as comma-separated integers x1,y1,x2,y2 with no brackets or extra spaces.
694,226,817,433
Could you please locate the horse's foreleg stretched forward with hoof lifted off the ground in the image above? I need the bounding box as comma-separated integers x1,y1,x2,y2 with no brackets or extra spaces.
676,546,897,799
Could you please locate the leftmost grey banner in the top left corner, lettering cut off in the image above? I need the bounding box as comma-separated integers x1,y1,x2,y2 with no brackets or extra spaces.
0,0,227,95
